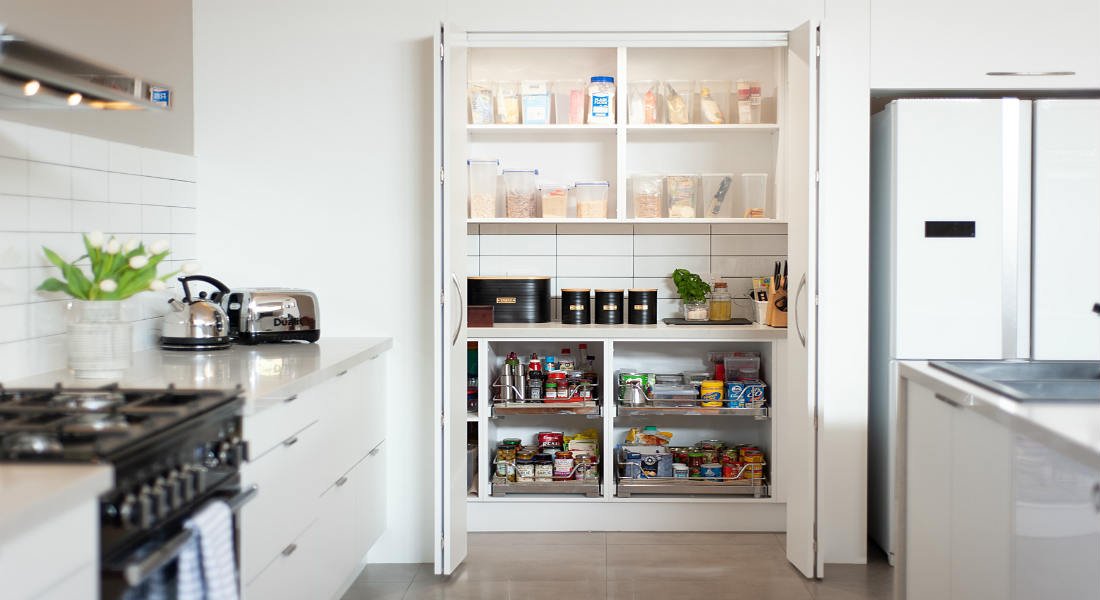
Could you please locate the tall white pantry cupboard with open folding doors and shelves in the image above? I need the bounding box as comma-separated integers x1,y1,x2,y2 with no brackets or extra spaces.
435,23,822,577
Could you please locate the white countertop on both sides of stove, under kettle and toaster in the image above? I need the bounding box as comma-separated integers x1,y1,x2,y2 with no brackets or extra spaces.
0,338,394,539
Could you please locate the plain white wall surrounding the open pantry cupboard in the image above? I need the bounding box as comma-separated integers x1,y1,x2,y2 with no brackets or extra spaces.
195,0,880,563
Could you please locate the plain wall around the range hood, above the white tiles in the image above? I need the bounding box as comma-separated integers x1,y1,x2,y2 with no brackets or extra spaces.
0,0,193,155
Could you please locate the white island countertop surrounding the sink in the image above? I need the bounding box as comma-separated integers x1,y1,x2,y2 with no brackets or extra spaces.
898,361,1100,469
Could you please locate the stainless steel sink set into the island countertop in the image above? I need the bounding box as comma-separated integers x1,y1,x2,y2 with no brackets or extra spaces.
930,360,1100,402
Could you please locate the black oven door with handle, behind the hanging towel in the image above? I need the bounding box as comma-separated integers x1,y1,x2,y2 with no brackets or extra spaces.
100,476,260,600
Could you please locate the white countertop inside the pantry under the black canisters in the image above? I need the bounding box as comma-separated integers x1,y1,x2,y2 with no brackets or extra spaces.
466,323,787,341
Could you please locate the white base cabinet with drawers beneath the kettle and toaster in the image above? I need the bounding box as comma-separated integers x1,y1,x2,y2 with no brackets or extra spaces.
241,358,386,600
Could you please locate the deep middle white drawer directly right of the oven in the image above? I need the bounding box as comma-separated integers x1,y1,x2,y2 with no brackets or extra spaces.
241,423,325,582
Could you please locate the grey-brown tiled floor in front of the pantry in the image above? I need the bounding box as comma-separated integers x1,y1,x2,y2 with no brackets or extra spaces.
343,533,893,600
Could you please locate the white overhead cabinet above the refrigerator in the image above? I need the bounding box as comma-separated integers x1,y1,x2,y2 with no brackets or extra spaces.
870,0,1100,90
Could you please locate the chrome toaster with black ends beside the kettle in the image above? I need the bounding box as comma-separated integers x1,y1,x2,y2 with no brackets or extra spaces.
221,287,321,345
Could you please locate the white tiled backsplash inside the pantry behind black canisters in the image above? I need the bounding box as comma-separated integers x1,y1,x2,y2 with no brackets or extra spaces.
466,223,787,318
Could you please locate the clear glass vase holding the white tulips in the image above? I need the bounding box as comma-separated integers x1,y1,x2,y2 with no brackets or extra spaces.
67,301,133,379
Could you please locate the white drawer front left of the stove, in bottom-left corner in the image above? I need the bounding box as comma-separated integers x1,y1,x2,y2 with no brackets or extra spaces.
0,500,99,600
